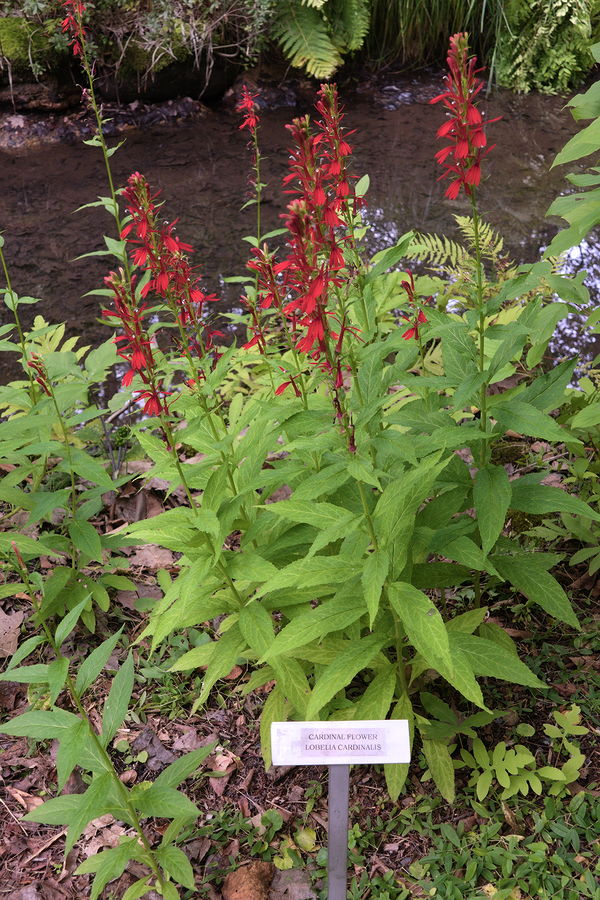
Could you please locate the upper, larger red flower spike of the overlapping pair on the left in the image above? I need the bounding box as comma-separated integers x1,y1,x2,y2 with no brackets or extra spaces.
121,172,222,376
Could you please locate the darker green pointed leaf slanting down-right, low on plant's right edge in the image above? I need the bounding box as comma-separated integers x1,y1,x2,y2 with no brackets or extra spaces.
492,553,580,629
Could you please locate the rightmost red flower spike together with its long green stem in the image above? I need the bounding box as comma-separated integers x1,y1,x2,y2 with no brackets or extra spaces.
430,33,498,466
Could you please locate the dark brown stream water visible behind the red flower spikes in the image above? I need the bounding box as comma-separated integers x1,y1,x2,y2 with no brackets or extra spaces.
0,76,600,377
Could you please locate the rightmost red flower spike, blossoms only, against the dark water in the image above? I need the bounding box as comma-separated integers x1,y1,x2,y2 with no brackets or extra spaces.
429,33,498,200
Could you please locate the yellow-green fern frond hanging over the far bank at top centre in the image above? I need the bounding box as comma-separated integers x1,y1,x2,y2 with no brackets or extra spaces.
273,0,342,78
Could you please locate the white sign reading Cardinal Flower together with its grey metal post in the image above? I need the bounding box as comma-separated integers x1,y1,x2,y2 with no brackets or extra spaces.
271,719,410,900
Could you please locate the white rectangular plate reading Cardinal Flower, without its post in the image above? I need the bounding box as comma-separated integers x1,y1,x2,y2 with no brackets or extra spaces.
271,719,410,766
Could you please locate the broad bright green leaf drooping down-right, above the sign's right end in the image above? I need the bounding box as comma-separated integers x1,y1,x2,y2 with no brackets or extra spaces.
389,582,453,672
